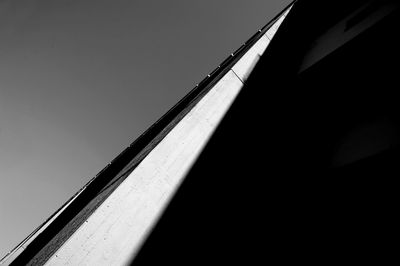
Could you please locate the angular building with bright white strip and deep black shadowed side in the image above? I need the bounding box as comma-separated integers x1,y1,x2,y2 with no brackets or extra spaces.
1,0,400,265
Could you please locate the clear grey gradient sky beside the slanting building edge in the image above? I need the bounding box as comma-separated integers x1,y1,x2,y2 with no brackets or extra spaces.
0,0,291,257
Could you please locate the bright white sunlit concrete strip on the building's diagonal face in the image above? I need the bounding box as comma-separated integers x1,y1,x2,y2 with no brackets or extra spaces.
46,8,294,265
